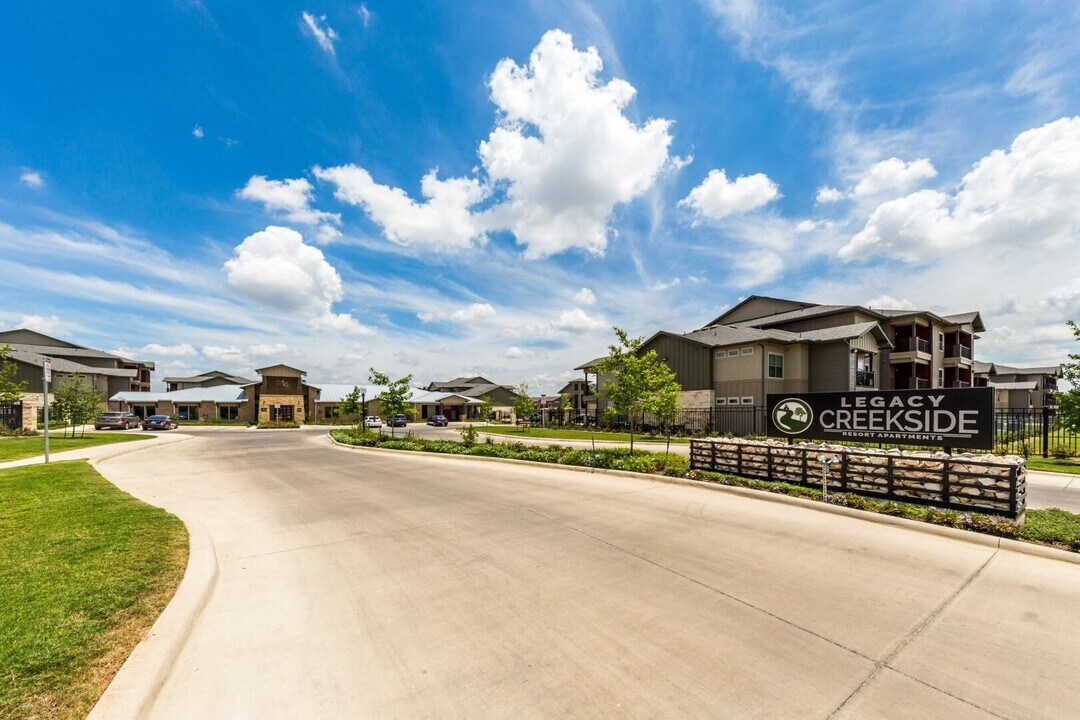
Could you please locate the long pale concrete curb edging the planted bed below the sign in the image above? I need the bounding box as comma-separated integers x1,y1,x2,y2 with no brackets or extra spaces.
326,434,1080,565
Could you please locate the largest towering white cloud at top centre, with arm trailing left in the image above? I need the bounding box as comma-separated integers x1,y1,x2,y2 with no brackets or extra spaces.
315,30,672,258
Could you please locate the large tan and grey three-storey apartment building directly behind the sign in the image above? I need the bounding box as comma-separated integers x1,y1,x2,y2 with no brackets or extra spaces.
577,296,985,409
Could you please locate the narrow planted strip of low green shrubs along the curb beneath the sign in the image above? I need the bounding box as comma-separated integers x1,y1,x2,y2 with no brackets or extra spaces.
330,430,1080,553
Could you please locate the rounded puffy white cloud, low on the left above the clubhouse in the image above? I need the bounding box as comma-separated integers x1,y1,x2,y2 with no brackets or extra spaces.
224,226,374,335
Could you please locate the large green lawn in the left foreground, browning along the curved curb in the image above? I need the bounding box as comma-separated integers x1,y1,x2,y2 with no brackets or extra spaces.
0,461,188,719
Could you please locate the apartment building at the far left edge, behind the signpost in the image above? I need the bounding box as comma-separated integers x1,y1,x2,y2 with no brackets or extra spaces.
0,328,154,430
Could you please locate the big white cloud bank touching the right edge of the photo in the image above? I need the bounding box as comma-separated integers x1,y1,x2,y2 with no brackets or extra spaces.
839,117,1080,261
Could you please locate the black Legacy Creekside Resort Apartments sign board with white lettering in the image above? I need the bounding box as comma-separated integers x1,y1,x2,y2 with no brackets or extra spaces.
768,388,994,449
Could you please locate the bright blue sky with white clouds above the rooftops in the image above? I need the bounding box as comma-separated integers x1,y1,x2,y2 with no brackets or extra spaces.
0,0,1080,392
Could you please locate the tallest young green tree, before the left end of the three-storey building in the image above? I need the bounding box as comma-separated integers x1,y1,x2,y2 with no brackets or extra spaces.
596,327,683,450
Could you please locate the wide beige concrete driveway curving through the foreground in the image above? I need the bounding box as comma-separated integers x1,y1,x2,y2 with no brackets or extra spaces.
100,431,1080,719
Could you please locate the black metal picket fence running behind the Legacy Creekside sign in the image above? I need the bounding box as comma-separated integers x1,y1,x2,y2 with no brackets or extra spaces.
544,405,1080,458
